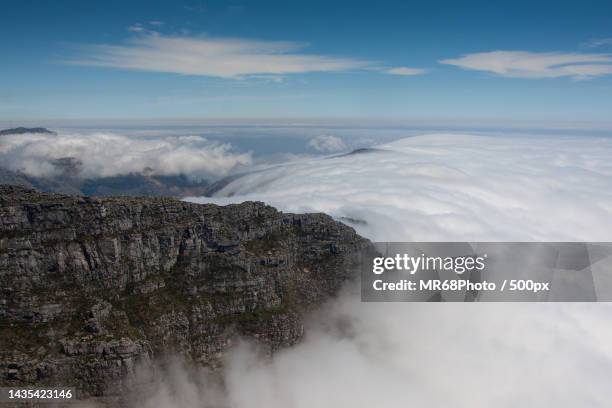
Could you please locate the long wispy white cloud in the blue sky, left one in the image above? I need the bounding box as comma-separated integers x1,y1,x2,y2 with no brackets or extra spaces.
69,33,370,78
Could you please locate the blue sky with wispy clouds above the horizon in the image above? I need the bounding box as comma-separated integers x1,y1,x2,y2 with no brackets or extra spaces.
0,0,612,122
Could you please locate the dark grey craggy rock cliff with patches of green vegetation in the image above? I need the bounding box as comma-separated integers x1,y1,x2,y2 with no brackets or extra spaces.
0,186,367,404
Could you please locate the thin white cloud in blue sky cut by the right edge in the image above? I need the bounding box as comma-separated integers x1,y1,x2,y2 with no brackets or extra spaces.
440,51,612,80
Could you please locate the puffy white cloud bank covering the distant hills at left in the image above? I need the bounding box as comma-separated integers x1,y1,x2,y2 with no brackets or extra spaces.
0,133,251,177
